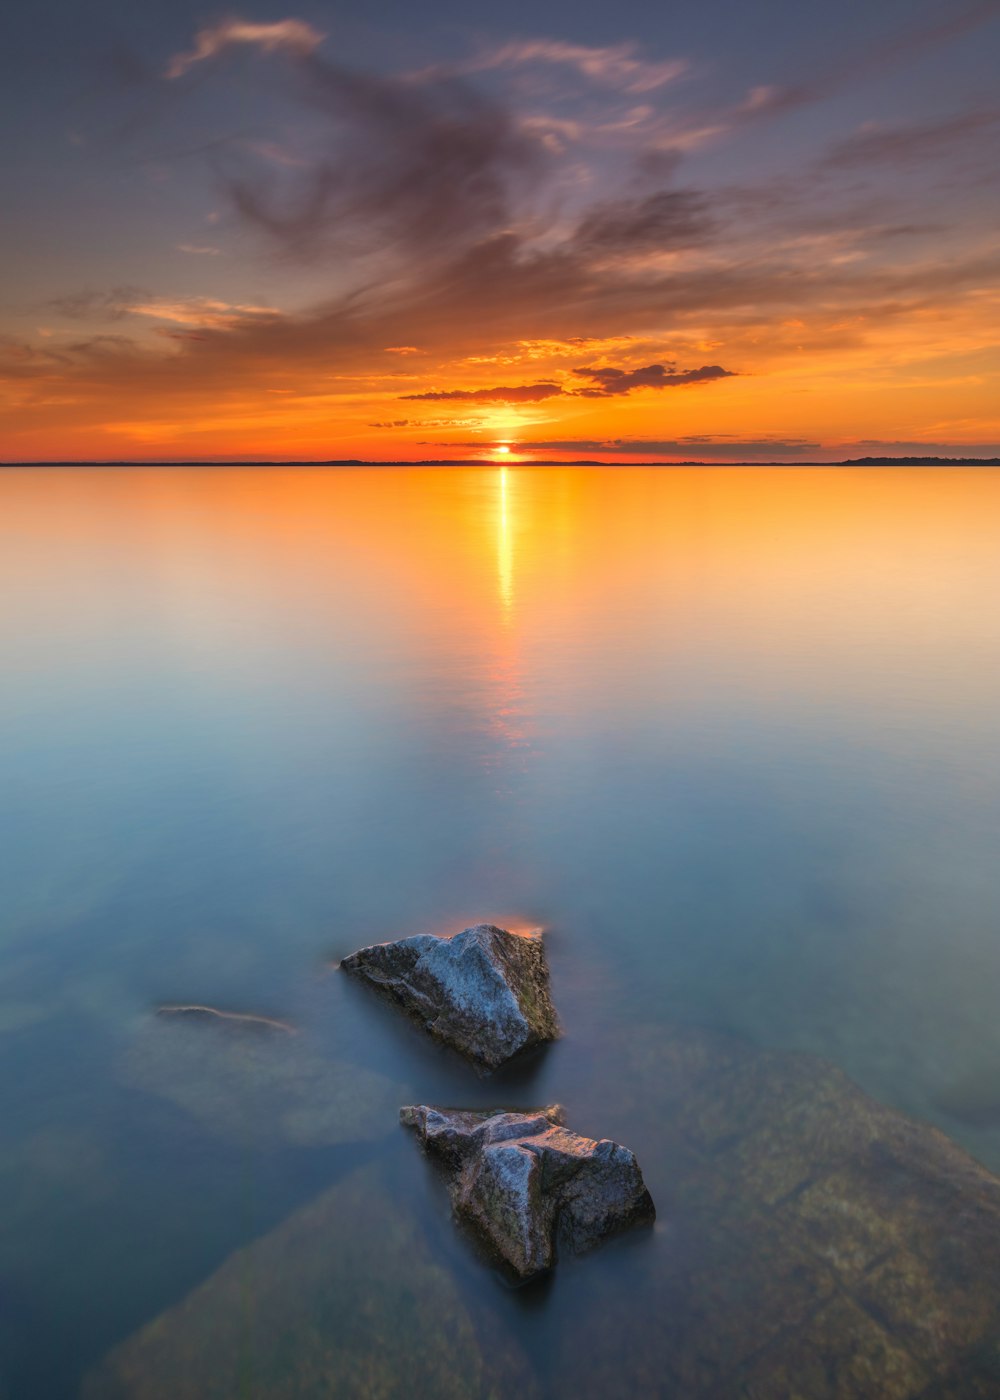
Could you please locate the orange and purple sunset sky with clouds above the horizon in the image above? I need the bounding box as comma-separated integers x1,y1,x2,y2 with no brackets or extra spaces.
0,0,1000,462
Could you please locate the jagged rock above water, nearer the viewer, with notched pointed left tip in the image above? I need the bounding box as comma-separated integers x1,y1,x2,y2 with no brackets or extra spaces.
399,1105,655,1280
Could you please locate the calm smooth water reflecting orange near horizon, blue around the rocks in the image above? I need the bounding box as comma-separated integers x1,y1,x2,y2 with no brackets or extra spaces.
0,468,1000,1400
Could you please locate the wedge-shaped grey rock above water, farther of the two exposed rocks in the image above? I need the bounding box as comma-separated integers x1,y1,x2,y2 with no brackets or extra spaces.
340,924,559,1072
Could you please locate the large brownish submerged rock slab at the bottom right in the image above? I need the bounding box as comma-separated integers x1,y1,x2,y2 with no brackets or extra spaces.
553,1025,1000,1400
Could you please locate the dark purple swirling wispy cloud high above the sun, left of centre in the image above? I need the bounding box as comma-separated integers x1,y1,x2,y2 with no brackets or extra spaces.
217,53,550,259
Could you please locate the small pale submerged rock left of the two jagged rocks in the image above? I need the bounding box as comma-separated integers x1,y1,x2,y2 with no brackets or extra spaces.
119,1007,401,1148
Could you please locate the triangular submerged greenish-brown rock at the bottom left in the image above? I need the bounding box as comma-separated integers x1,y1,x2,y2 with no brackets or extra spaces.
83,1170,538,1400
